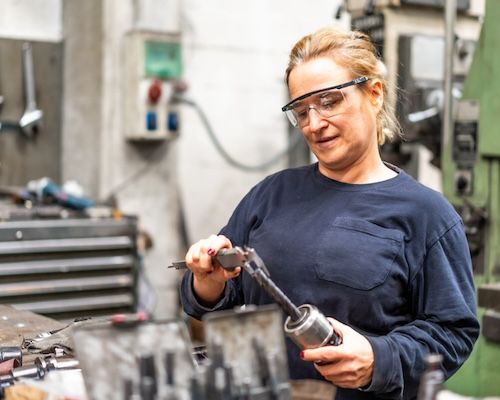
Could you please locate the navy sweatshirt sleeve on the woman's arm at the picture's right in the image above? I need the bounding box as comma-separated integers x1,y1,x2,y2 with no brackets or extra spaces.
364,222,479,399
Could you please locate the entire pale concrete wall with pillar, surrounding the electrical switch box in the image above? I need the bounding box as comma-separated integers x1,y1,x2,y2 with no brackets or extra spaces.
0,0,344,317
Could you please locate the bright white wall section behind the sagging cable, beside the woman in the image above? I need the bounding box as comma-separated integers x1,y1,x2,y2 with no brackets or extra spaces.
179,0,344,241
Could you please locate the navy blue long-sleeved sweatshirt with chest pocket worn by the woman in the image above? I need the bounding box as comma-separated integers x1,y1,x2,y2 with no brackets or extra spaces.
181,164,479,400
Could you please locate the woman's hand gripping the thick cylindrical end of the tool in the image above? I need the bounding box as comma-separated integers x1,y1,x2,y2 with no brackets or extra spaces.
301,318,374,389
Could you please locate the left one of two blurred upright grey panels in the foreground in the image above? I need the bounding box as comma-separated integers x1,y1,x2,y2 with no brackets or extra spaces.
73,315,198,400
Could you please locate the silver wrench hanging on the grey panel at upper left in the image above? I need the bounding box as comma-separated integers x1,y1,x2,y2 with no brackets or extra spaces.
19,43,43,137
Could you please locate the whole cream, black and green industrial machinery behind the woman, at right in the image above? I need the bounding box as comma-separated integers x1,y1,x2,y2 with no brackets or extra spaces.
348,0,500,397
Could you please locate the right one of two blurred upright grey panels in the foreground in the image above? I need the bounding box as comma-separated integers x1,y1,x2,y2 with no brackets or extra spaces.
201,305,291,400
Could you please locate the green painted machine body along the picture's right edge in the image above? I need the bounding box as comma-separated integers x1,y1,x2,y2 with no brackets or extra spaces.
442,0,500,396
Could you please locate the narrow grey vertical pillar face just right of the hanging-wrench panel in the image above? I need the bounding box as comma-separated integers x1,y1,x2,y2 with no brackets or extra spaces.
62,0,103,198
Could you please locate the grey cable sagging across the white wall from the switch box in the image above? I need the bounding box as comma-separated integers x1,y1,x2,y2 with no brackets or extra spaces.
173,94,302,172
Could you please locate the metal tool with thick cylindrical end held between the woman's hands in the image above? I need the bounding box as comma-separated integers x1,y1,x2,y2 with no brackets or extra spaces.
169,247,342,349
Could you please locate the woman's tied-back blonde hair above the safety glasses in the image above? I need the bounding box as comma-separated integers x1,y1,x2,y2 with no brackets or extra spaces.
285,27,401,145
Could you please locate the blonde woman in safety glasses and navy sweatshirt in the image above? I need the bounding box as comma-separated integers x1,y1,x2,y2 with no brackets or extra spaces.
181,28,479,399
